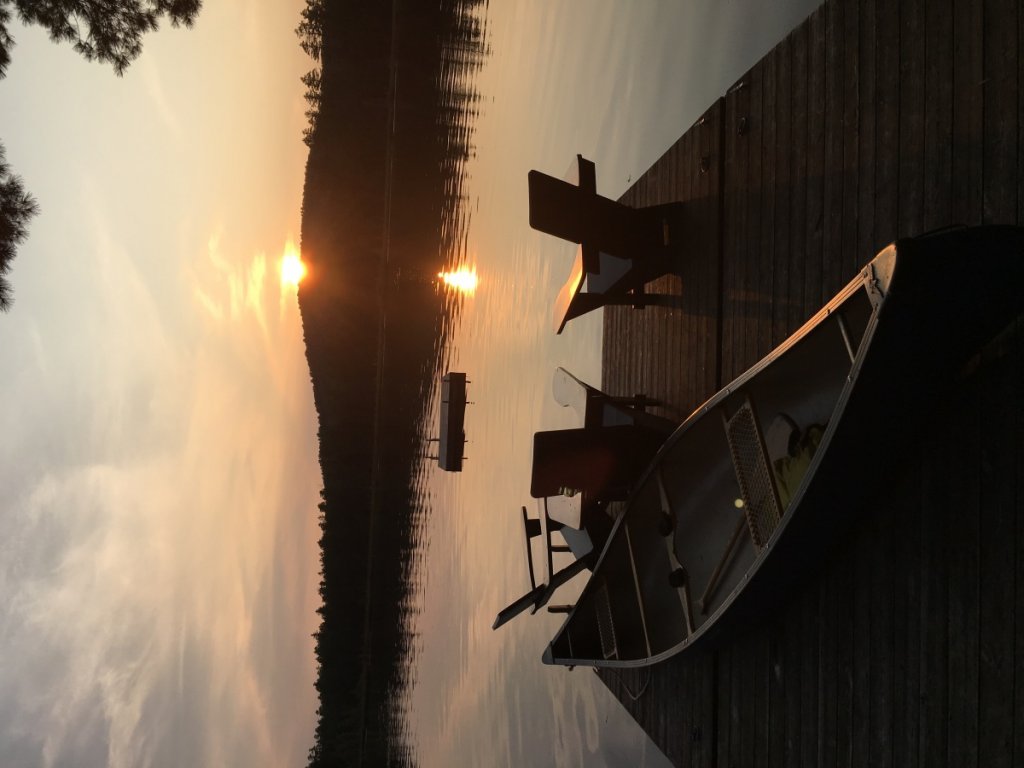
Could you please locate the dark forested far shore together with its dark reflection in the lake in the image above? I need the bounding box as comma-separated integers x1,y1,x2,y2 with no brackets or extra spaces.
297,0,485,766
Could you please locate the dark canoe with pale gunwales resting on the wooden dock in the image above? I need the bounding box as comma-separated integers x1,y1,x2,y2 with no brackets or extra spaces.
544,226,1024,667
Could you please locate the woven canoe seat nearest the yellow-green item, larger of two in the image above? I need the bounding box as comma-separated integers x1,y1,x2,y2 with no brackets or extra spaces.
722,395,782,551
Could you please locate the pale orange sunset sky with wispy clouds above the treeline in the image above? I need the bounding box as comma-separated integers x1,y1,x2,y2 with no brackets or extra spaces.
0,0,322,766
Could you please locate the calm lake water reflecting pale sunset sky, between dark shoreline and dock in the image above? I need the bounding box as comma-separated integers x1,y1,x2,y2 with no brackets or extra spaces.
402,0,818,766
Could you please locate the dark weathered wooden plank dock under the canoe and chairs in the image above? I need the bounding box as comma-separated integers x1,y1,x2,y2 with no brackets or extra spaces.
598,0,1024,768
